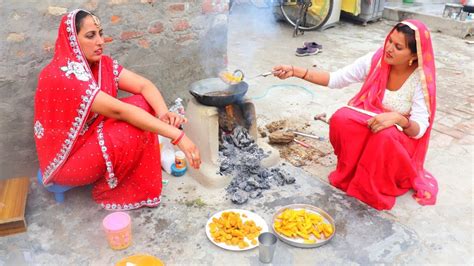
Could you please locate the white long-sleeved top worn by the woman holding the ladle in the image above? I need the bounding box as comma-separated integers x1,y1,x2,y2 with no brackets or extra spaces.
328,53,430,139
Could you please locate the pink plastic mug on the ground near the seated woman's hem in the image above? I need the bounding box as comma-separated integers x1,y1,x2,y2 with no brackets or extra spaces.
102,212,132,250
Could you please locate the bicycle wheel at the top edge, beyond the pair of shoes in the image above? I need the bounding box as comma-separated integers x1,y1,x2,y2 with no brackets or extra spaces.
280,0,334,31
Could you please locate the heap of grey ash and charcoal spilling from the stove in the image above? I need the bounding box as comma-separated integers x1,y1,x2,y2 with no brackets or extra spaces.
219,126,295,204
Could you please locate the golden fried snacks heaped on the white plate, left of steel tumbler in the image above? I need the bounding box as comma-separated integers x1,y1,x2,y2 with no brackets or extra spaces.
209,212,262,249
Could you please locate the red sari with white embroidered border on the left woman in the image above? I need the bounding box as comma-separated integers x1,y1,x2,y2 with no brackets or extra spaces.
34,10,162,210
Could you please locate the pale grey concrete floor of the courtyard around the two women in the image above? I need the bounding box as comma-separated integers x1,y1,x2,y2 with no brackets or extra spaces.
0,2,474,266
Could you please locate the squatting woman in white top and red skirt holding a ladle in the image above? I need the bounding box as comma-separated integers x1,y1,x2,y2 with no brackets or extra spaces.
274,20,438,210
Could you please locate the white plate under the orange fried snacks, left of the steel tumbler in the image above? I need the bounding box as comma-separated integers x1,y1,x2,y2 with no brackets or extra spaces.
206,209,268,251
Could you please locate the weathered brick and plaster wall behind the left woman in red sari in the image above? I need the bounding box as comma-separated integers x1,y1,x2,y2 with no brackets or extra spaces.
0,0,228,179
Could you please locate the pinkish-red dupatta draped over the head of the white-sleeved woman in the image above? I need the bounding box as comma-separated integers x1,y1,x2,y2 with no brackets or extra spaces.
349,20,438,205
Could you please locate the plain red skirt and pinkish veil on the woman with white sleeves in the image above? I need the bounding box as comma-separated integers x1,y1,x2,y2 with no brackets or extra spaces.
329,20,438,210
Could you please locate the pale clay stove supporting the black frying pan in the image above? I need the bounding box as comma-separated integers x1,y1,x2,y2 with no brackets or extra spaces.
184,98,280,188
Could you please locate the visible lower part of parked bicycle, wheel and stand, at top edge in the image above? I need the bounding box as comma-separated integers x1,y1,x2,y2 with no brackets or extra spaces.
279,0,334,37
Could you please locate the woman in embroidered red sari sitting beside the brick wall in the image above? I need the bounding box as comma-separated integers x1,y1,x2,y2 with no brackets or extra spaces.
34,10,201,210
